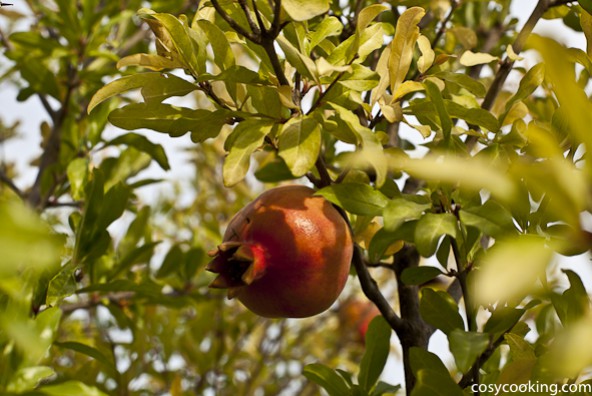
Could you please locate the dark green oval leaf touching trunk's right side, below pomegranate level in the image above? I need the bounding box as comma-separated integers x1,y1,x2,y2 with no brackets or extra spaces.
419,288,464,335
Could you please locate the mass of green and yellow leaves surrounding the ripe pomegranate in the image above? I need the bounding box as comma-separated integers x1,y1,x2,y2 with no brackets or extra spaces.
0,0,592,396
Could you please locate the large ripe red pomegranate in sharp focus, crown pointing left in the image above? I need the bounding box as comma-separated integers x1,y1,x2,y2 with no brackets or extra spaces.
207,185,353,318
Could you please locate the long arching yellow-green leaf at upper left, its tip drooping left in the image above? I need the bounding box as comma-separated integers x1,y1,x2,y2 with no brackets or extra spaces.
87,72,197,113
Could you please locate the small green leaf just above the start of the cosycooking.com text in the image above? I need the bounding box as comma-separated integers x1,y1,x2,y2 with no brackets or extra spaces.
448,329,489,373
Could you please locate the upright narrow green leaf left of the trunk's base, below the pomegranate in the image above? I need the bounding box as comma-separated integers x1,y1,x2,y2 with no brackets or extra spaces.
358,315,391,392
